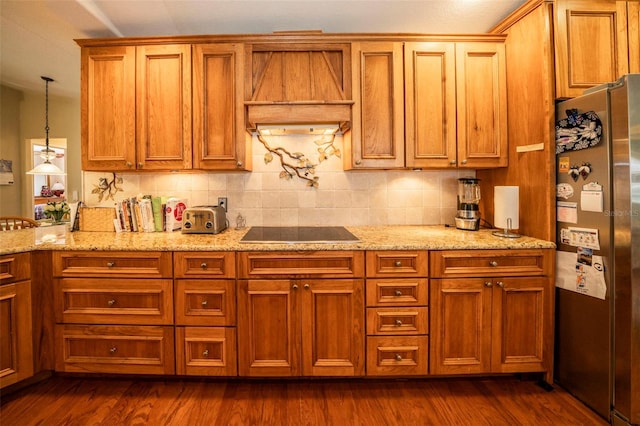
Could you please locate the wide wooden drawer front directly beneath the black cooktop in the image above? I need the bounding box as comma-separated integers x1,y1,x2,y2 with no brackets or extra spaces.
238,251,364,278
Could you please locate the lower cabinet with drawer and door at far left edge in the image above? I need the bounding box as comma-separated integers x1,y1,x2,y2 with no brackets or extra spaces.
0,253,34,389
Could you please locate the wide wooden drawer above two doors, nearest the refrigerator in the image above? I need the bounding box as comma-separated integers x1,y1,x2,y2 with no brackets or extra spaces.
431,249,554,278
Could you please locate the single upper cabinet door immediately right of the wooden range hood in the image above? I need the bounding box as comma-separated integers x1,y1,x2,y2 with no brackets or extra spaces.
345,42,404,169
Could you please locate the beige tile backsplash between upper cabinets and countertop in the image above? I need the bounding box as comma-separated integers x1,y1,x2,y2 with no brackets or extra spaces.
82,136,475,226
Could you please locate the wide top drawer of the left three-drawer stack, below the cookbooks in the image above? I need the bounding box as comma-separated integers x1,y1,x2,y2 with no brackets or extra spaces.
53,251,173,278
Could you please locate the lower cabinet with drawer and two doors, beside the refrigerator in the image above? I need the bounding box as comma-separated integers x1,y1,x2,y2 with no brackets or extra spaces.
429,249,554,383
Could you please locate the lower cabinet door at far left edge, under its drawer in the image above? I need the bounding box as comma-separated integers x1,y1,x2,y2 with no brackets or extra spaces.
0,281,33,388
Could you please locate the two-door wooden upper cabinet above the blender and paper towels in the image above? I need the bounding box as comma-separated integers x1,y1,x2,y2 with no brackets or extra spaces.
404,41,508,169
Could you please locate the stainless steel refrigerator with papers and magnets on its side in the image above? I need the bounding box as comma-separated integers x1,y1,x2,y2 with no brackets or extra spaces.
555,74,640,425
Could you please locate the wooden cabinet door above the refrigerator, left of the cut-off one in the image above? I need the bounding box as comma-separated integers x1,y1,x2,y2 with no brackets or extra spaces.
555,0,629,98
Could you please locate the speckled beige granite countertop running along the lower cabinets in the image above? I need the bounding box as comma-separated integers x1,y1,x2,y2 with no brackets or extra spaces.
0,226,555,255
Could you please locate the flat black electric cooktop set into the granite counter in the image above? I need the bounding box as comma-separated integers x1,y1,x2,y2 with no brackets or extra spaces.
240,226,360,244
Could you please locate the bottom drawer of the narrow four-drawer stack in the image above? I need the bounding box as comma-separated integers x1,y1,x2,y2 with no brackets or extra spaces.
367,336,429,376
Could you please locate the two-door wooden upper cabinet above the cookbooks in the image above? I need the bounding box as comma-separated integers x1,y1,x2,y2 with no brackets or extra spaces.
81,44,192,171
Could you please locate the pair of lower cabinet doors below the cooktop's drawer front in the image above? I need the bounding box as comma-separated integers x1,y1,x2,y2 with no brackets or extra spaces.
238,279,364,376
